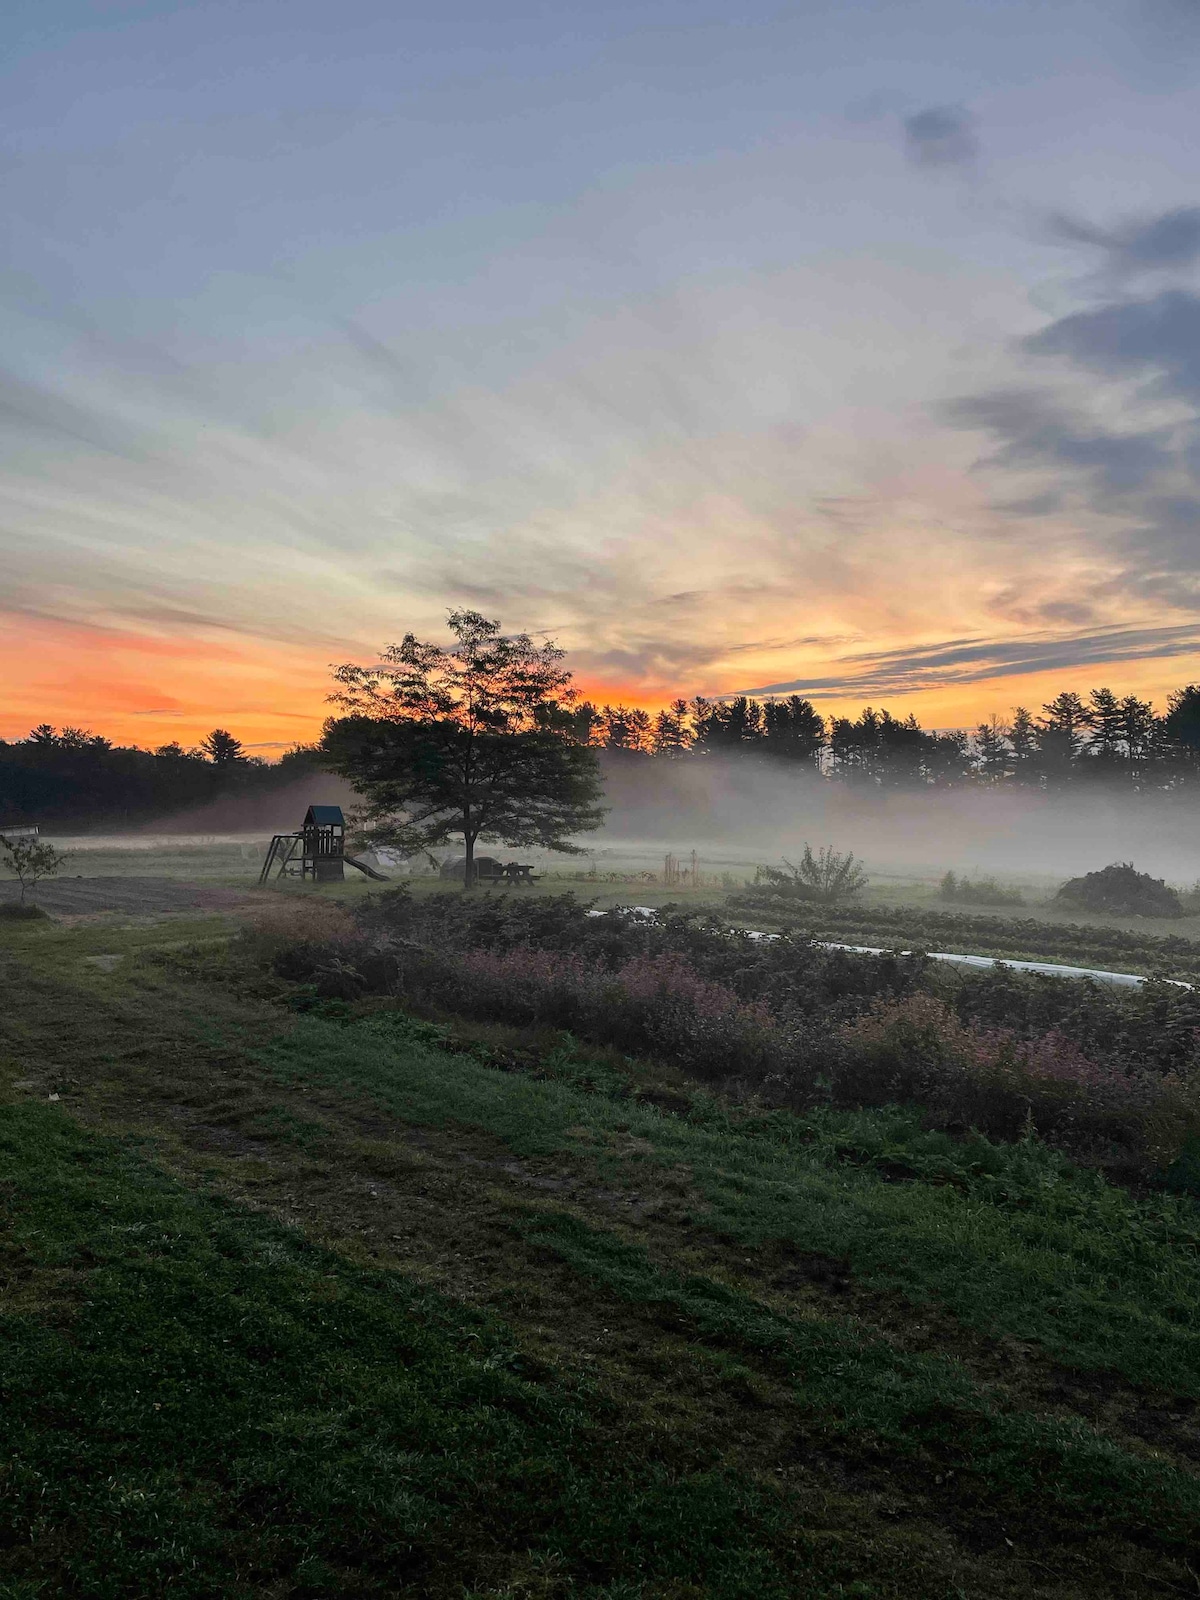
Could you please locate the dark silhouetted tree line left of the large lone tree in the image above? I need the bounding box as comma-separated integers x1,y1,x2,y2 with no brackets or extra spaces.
0,723,322,832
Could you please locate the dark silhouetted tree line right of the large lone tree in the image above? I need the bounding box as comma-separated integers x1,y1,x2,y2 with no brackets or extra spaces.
562,683,1200,787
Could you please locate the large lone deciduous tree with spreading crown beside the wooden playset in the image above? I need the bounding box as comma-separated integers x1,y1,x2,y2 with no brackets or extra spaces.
323,611,603,888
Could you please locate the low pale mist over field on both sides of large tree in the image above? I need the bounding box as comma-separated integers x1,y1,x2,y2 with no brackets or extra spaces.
56,752,1200,885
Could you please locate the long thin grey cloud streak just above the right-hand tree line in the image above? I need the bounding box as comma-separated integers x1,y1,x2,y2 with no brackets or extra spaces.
741,622,1200,694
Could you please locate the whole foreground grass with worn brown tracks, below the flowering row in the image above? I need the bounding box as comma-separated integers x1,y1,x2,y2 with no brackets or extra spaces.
0,920,1200,1600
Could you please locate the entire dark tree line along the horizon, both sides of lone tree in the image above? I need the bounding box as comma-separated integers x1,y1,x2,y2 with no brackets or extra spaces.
0,683,1200,826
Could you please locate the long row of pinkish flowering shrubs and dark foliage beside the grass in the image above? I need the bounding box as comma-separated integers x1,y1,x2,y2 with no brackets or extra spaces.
254,893,1200,1171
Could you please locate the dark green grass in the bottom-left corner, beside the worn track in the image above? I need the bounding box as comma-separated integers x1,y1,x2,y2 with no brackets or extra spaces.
0,1106,838,1597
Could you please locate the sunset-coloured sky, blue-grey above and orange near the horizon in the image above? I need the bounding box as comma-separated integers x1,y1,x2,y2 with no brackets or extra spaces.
0,0,1200,755
